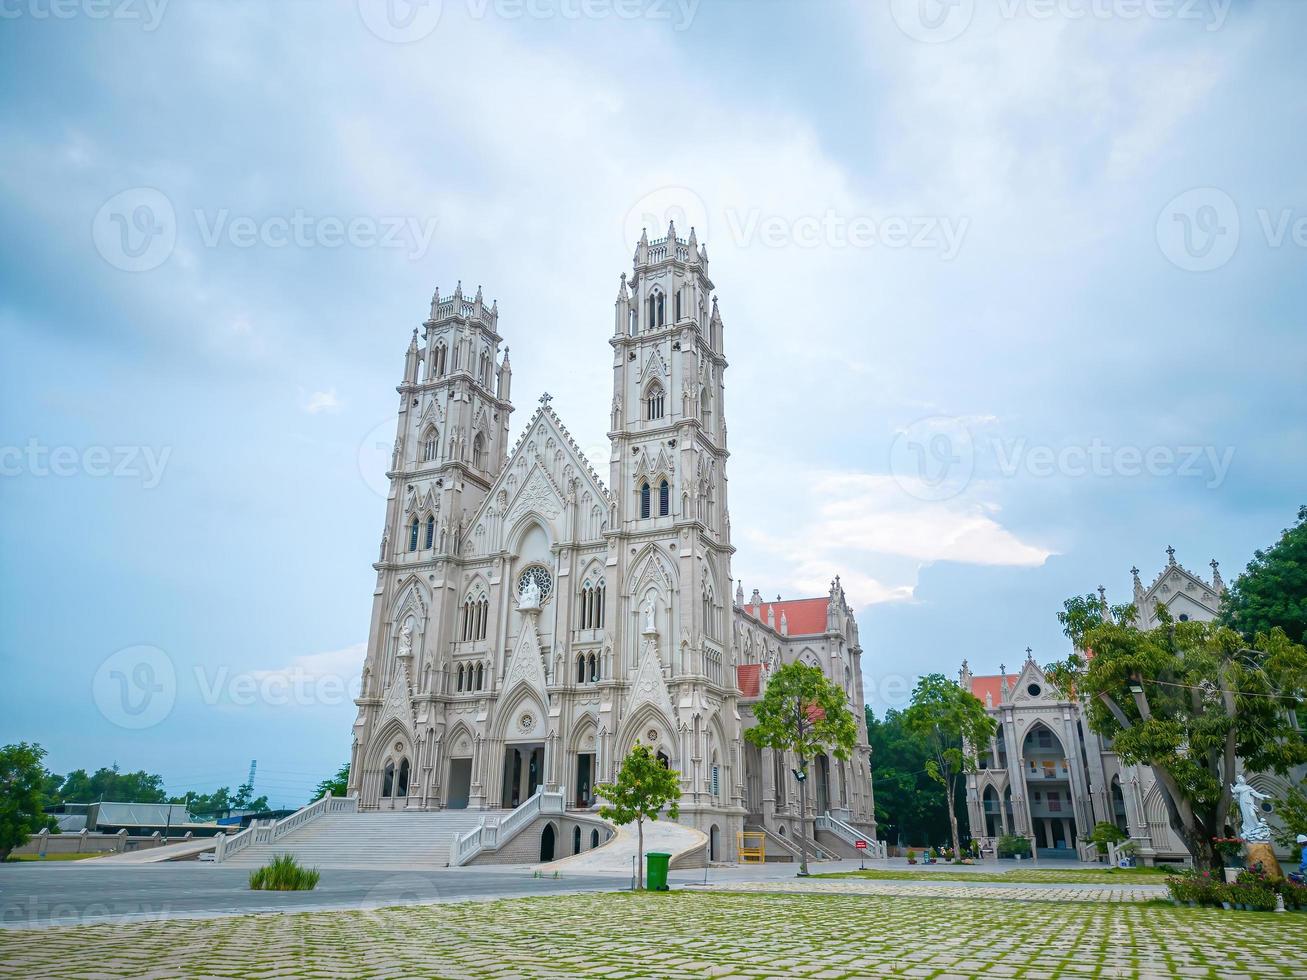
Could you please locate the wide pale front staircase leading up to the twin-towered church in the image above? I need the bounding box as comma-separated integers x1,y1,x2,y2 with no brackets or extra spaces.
218,810,488,870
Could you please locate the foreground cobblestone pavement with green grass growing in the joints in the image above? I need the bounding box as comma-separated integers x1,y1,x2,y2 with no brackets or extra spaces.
0,891,1307,980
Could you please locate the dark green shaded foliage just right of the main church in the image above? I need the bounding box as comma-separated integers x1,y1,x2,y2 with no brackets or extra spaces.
865,706,962,845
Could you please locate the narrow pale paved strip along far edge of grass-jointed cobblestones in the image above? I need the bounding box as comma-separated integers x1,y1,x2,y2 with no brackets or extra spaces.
716,878,1167,902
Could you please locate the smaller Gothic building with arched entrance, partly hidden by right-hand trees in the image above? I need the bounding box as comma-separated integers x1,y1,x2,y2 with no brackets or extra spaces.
959,547,1287,864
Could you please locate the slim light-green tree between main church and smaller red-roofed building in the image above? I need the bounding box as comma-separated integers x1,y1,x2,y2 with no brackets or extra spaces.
903,674,995,855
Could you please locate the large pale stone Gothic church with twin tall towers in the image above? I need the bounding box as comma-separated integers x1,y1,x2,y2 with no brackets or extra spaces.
350,226,874,860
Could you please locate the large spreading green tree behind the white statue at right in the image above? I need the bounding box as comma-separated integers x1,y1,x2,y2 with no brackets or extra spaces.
1046,596,1307,870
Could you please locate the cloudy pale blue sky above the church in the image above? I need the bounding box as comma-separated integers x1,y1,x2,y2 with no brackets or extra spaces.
0,0,1307,802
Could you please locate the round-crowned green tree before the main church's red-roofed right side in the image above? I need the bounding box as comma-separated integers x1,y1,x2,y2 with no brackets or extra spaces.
744,661,857,875
